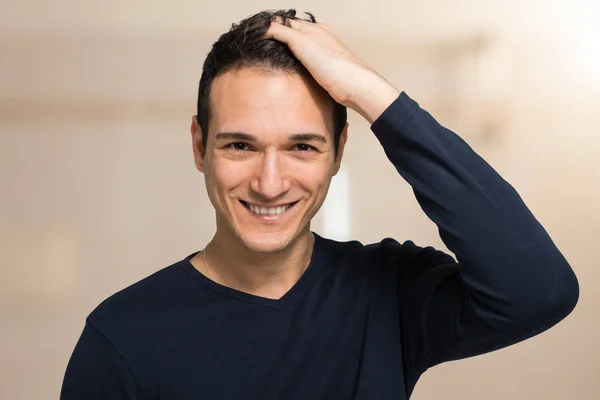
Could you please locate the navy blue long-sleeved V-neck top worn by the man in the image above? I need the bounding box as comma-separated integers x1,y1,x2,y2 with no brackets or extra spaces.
61,92,579,400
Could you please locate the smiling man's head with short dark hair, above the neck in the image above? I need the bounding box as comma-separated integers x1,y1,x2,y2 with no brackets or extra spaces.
191,10,347,252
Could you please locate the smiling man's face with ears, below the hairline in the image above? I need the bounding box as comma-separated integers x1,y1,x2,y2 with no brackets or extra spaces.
191,68,347,252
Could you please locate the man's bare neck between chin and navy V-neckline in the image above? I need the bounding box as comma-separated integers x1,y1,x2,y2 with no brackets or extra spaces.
191,229,314,299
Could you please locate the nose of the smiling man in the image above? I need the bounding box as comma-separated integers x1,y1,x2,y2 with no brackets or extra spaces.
251,151,290,200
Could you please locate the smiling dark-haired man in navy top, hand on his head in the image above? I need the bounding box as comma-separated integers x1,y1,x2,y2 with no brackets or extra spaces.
61,10,579,400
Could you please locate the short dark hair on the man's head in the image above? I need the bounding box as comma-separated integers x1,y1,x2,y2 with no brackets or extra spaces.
196,9,347,156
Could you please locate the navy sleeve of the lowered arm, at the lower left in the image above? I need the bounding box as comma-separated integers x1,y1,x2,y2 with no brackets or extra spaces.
60,321,143,400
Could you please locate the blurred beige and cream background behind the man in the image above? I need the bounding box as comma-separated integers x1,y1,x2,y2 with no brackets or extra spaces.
0,0,600,400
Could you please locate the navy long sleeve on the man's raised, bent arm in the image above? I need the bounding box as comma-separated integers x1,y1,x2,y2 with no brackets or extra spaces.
371,92,579,383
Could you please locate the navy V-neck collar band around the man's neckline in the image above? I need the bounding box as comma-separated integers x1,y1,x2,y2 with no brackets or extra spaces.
180,232,324,310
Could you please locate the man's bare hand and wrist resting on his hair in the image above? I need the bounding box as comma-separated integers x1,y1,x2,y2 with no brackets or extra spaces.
265,19,400,124
